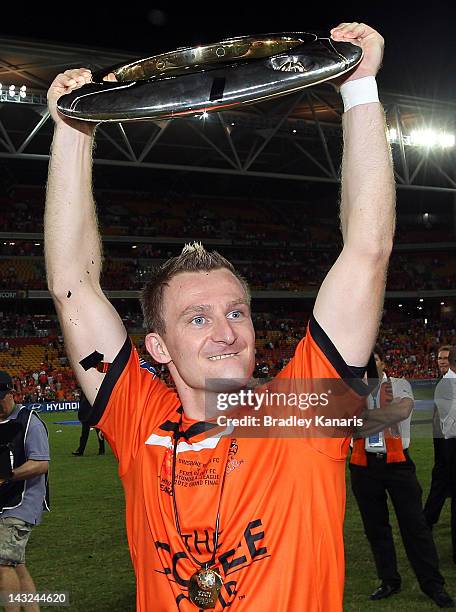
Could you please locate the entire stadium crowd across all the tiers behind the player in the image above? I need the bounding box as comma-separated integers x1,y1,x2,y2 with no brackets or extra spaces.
0,189,456,403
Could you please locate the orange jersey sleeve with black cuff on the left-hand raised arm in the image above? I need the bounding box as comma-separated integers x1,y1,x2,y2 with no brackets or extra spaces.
80,338,179,477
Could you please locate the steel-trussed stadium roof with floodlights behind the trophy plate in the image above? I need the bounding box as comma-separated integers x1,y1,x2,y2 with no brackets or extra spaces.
0,38,456,193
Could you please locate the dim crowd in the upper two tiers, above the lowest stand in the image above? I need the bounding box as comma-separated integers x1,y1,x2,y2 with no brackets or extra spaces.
0,189,456,291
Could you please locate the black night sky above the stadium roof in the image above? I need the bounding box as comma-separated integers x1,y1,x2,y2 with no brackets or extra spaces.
0,0,456,100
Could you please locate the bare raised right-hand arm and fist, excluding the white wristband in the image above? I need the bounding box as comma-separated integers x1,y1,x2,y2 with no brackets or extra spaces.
314,23,395,366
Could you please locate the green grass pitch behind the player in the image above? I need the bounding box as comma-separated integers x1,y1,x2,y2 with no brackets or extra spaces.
27,412,456,612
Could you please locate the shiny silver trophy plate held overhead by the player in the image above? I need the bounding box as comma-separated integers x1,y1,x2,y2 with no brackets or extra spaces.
57,32,363,122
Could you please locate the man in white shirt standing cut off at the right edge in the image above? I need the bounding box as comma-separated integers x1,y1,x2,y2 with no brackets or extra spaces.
434,347,456,563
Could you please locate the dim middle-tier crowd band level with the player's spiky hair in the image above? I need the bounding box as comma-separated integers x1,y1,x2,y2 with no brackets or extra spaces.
0,247,456,291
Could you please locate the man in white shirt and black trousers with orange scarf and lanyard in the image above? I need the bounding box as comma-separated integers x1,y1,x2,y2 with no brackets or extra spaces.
350,346,455,608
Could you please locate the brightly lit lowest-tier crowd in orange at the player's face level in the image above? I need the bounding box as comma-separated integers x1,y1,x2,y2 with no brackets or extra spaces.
0,312,456,403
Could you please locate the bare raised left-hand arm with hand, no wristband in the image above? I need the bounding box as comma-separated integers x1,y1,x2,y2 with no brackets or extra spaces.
44,69,126,403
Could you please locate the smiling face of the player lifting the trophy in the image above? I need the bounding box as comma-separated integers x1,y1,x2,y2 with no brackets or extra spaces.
146,268,255,407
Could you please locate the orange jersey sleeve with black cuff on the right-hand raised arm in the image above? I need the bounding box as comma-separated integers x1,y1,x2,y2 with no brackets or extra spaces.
278,316,369,460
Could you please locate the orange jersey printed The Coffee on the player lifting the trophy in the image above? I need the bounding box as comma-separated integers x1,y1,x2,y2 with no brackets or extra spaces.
91,319,368,612
